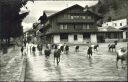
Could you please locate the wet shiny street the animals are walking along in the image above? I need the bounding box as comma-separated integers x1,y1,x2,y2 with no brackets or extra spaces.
25,43,127,81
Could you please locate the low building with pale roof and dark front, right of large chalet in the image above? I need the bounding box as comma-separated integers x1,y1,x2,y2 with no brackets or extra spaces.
97,26,123,42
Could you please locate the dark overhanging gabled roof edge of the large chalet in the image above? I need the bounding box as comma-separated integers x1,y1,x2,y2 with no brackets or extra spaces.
48,4,102,18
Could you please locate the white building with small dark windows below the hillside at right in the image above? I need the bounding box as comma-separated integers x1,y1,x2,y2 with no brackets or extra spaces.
102,19,128,29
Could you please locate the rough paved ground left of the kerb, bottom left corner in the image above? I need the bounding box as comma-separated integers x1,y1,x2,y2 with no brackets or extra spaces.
0,47,23,82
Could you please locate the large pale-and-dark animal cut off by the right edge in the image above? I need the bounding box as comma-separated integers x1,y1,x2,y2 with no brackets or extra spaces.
116,48,128,68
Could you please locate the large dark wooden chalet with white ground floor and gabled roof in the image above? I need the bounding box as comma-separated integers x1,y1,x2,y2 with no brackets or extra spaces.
41,4,102,43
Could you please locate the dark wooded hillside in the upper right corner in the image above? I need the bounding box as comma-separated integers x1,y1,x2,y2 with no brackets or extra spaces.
91,0,128,21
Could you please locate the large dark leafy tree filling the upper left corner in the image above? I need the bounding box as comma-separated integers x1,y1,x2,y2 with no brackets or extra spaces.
0,0,33,43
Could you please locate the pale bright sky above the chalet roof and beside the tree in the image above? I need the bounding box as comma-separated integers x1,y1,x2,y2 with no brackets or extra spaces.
21,0,98,31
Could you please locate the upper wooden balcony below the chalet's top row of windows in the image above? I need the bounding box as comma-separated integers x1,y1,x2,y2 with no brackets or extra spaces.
57,19,95,23
